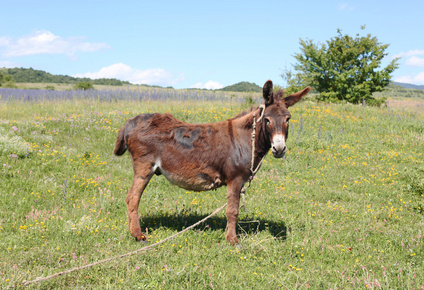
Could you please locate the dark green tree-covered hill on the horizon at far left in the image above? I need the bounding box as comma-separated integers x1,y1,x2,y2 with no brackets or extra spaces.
0,68,131,86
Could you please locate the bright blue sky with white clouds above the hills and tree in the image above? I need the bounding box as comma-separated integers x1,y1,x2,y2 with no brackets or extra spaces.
0,0,424,89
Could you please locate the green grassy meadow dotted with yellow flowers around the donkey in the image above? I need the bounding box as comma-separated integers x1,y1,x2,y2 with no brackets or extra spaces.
0,97,424,289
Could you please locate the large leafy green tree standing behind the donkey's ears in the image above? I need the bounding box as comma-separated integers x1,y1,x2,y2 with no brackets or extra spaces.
282,27,398,105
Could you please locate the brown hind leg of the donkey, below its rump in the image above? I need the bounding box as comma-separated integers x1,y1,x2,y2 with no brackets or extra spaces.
126,162,154,242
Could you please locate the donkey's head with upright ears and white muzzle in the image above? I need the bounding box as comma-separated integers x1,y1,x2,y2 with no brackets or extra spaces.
263,81,311,158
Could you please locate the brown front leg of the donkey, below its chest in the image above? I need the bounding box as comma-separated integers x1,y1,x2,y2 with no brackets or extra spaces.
226,178,244,245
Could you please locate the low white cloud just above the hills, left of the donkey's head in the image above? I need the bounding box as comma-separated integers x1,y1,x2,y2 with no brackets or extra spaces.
74,63,184,86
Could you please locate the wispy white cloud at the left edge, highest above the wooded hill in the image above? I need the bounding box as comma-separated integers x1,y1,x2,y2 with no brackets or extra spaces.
0,30,109,57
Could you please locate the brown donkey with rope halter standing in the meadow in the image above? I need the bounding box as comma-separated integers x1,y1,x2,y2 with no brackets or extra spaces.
114,81,310,244
